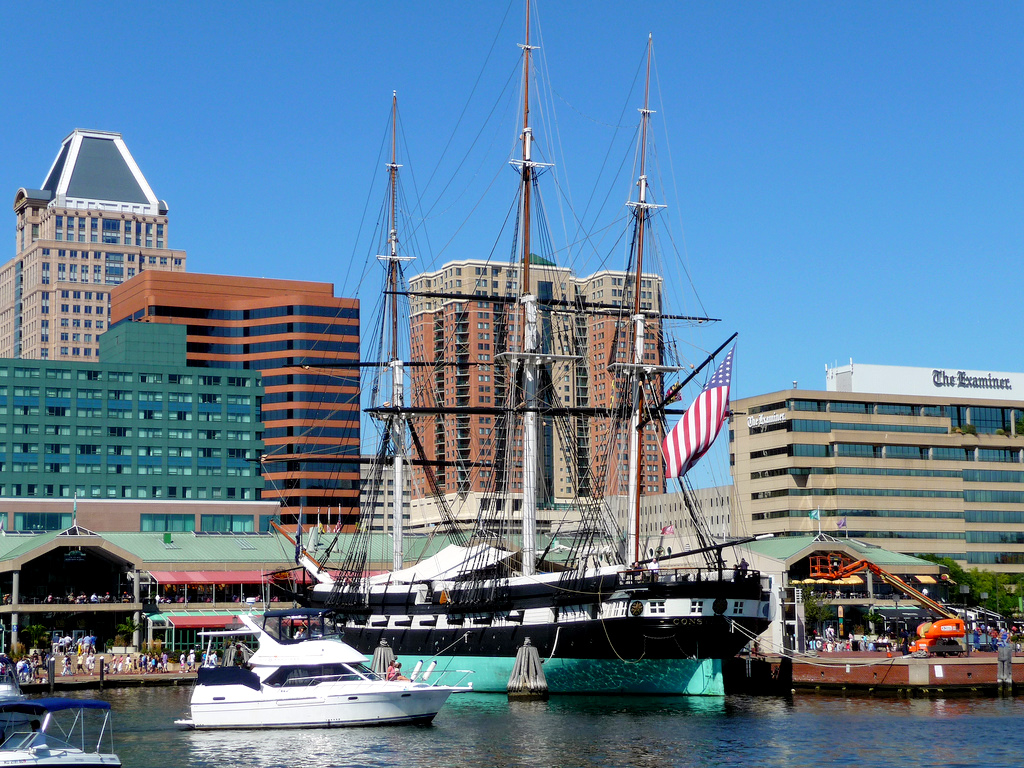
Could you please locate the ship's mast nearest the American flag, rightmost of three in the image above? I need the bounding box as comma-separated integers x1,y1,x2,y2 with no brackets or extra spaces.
626,35,664,562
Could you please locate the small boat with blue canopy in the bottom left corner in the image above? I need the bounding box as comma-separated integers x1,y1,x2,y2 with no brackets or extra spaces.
0,698,121,768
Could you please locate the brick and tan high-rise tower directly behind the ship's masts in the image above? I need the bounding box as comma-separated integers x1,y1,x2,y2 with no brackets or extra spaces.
410,260,665,528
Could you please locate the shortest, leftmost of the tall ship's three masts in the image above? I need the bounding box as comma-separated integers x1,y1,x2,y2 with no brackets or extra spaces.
377,91,411,570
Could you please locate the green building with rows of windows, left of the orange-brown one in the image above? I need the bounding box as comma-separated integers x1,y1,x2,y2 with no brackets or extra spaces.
0,324,263,501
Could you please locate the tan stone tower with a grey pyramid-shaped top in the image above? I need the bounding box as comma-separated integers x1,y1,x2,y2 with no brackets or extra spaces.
7,129,185,360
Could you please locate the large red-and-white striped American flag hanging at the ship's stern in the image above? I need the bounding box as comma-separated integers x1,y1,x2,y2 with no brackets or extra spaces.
662,347,736,477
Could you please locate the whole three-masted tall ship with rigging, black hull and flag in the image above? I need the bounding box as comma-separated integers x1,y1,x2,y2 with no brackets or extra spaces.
283,2,774,695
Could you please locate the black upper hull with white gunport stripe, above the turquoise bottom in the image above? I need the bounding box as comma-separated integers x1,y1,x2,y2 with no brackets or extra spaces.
311,573,770,660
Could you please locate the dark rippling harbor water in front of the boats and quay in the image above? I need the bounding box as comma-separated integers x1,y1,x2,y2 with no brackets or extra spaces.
70,687,1024,768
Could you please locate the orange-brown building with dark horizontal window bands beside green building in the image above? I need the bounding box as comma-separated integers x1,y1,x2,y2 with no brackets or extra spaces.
111,271,359,525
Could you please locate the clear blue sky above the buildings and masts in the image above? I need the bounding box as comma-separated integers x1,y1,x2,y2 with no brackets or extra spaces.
0,0,1024,409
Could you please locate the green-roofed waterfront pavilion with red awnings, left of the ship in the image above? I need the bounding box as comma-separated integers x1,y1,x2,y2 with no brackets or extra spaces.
0,524,301,650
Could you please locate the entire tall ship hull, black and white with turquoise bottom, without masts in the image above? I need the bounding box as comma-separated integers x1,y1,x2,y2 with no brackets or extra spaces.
314,571,773,695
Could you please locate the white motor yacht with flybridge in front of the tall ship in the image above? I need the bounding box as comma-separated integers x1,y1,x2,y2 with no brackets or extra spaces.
177,608,469,729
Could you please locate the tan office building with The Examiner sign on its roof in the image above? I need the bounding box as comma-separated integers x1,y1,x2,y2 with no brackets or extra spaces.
729,362,1024,571
